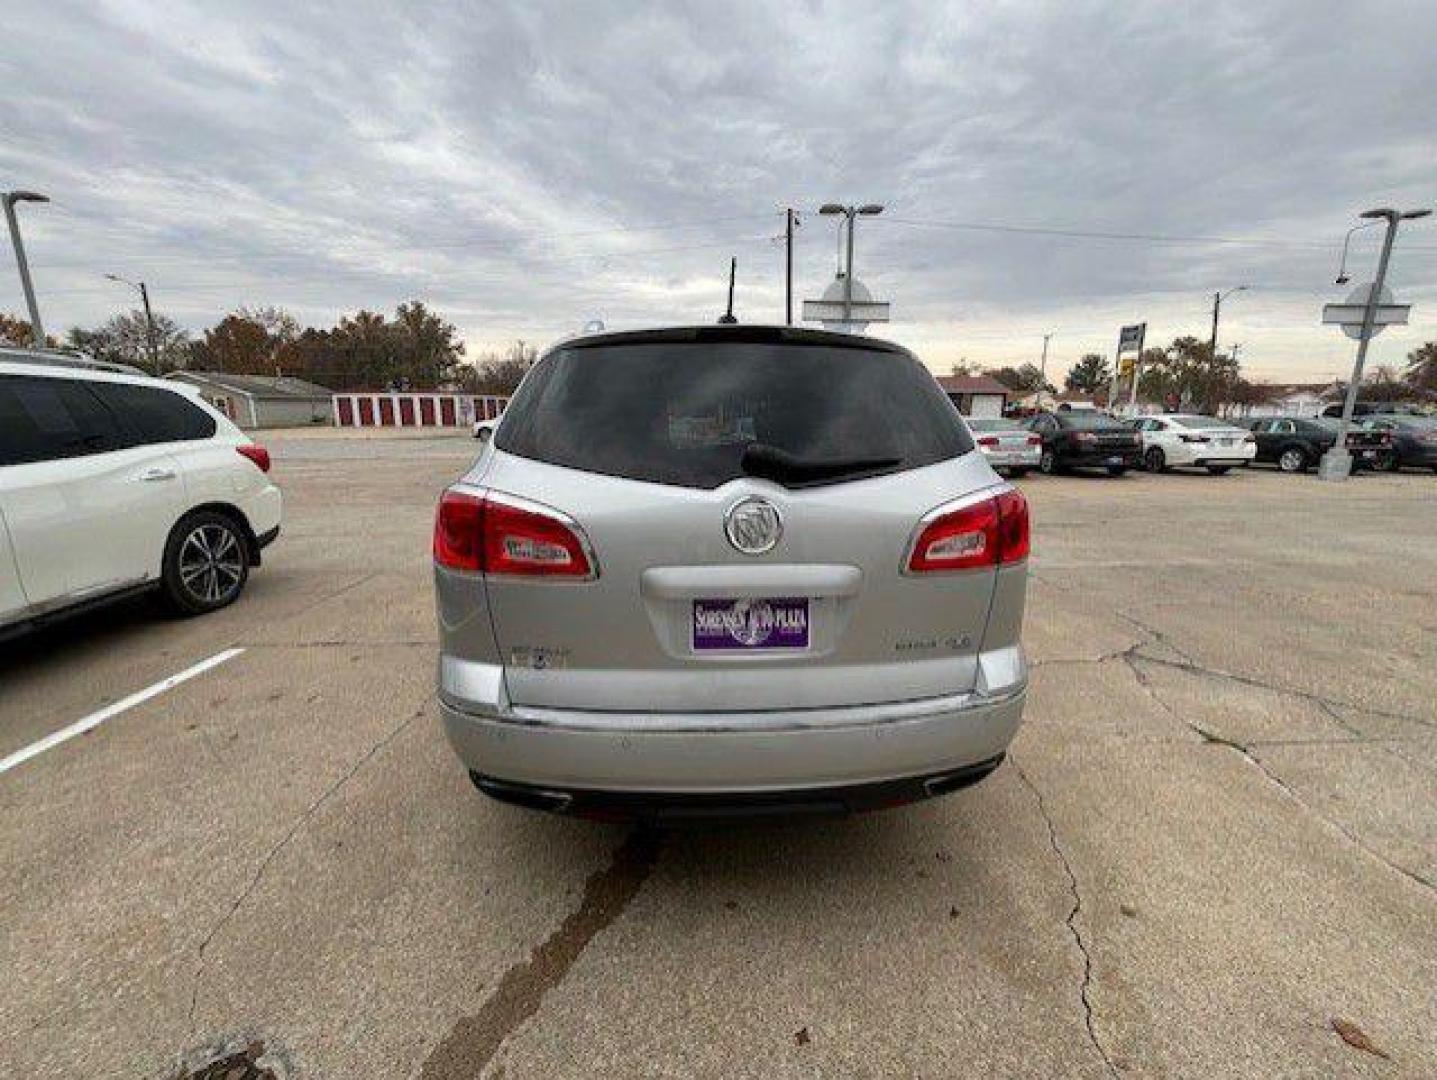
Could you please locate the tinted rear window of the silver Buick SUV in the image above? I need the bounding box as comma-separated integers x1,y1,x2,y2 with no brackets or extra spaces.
494,342,973,488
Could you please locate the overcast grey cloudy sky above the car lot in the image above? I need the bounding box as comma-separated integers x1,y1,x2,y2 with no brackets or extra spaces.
0,0,1437,381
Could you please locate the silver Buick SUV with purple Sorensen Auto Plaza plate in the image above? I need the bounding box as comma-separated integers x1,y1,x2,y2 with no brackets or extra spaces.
434,326,1029,819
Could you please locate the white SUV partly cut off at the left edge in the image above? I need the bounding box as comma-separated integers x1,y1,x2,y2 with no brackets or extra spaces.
0,349,280,636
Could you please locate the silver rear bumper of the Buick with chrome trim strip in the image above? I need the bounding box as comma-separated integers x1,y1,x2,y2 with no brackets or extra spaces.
440,648,1027,803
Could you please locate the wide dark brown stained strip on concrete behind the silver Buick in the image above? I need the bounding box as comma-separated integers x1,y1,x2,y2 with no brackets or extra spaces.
420,826,661,1080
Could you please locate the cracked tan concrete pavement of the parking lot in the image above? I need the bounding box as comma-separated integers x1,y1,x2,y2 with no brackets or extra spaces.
0,434,1437,1077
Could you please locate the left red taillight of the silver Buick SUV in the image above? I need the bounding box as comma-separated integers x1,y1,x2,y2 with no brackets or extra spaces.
434,490,599,580
